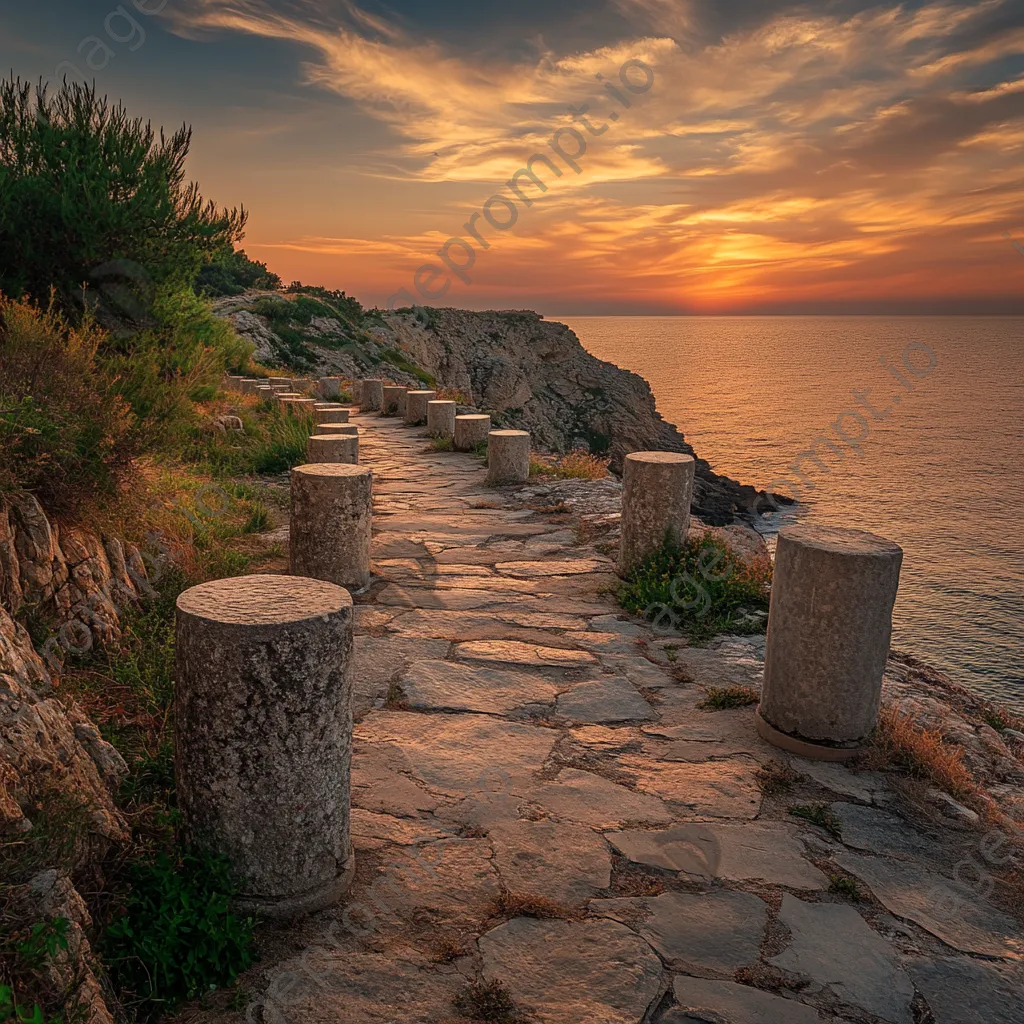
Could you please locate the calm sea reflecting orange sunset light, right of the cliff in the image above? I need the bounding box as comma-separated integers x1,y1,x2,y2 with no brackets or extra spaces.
561,316,1024,711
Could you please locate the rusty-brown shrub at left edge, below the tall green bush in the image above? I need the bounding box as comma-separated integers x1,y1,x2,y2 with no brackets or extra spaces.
0,296,142,513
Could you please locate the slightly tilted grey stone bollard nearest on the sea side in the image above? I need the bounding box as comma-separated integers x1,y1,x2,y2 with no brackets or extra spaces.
757,525,903,761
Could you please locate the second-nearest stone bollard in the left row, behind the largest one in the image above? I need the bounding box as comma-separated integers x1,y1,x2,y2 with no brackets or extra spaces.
289,464,373,590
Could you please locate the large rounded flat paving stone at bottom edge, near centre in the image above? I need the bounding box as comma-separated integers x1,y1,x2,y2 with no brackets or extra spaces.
479,918,662,1024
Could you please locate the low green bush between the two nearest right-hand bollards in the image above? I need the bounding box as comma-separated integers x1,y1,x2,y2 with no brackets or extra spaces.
618,537,771,640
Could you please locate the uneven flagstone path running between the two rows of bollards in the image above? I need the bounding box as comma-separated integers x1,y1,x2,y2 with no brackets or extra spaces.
237,416,1024,1024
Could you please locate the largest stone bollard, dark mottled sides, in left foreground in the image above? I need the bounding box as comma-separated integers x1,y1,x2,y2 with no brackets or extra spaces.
174,575,355,919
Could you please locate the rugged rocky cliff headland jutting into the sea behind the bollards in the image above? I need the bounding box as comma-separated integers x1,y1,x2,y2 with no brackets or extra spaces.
214,292,790,526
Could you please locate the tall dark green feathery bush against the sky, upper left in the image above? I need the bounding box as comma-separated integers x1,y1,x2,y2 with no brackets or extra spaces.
0,78,246,315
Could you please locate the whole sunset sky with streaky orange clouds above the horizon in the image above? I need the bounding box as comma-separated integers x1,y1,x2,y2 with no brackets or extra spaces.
0,0,1024,314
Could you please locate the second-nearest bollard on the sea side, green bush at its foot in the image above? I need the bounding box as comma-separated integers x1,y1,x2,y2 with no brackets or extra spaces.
618,452,696,575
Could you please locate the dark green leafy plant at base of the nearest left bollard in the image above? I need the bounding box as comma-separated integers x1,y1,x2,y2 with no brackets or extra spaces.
102,850,253,1016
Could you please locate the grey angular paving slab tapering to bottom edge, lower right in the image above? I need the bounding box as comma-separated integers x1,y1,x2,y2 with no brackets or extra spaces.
771,893,913,1024
